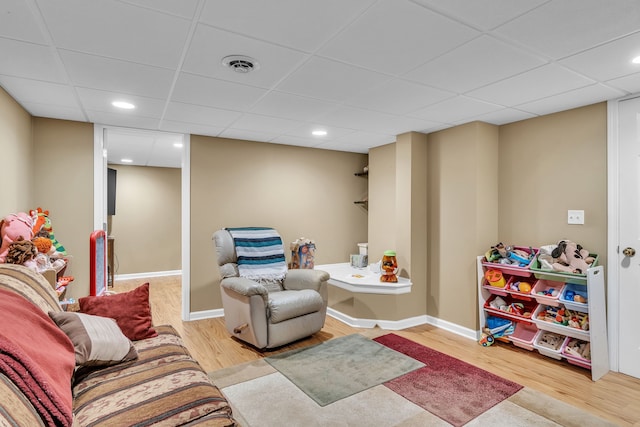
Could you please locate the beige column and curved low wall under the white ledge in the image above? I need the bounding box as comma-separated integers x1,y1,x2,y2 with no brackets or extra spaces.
329,132,427,321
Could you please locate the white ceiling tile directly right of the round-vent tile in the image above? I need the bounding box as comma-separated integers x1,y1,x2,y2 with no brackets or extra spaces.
277,57,388,102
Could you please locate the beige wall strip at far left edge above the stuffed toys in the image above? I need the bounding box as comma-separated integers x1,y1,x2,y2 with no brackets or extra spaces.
0,87,34,218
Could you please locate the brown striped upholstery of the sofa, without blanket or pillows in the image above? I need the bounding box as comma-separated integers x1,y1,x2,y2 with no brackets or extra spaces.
0,264,237,426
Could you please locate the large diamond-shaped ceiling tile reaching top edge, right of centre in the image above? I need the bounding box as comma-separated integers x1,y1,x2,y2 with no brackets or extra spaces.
319,0,479,75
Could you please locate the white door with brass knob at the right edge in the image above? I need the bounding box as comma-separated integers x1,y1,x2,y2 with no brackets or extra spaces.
609,98,640,378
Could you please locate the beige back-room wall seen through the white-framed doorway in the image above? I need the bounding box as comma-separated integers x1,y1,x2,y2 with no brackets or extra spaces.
109,165,182,275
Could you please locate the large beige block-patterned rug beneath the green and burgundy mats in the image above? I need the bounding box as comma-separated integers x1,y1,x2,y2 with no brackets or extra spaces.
209,341,616,427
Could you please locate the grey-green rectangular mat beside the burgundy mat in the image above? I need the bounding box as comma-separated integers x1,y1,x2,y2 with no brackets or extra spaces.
265,334,424,406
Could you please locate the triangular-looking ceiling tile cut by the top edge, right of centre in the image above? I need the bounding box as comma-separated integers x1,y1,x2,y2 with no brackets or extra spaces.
414,0,548,30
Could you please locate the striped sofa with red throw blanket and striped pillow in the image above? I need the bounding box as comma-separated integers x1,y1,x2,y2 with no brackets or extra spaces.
0,264,237,426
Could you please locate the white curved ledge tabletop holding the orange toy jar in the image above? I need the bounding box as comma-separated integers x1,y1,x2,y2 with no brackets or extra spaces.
315,262,411,295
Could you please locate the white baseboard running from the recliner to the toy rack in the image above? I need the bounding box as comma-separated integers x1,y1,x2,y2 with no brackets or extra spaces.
327,307,478,341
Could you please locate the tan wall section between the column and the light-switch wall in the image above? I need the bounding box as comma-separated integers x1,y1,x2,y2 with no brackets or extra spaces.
427,122,499,330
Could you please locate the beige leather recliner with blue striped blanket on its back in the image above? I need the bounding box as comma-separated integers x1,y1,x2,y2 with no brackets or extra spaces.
213,228,329,349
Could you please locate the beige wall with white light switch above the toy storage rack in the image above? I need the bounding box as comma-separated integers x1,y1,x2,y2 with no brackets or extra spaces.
499,103,607,266
